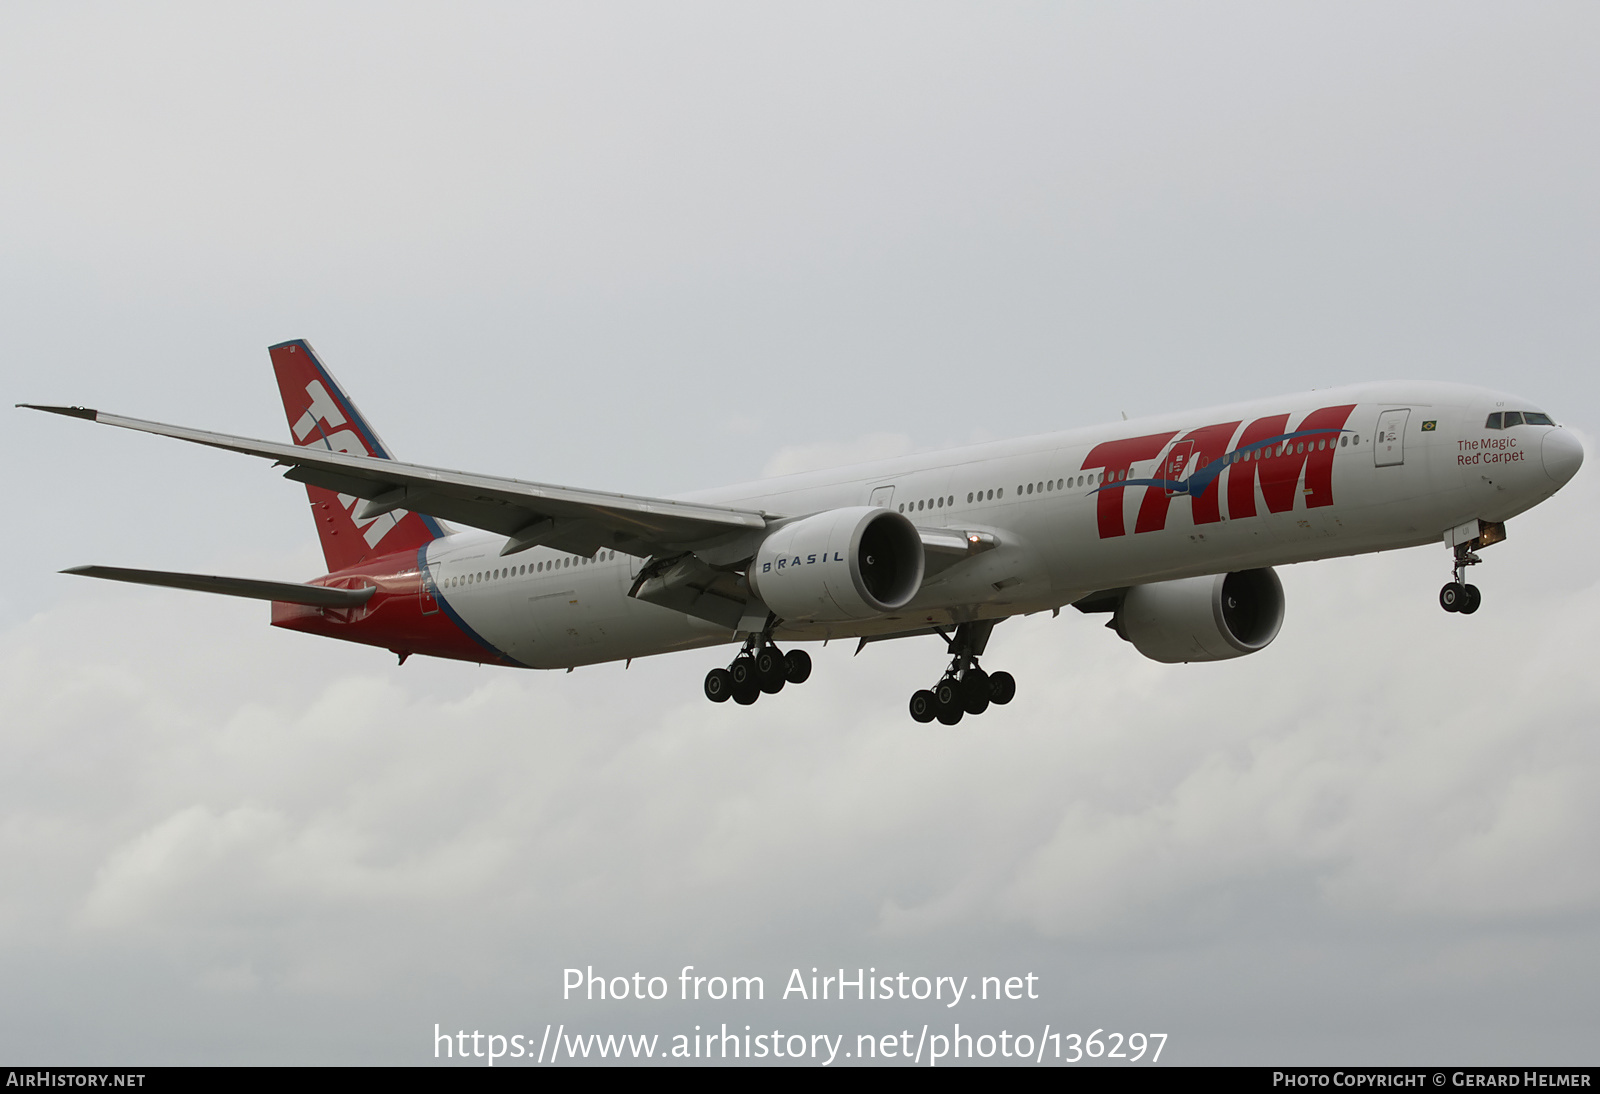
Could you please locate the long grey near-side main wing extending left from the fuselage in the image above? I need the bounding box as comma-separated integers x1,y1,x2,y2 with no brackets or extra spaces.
19,403,768,555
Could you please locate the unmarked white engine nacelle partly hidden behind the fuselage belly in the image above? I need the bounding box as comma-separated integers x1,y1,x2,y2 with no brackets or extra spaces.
1112,569,1283,664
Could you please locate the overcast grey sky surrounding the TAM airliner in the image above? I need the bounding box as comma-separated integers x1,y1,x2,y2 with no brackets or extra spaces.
0,0,1600,1064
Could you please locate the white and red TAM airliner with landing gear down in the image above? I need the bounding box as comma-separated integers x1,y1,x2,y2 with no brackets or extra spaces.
18,339,1584,726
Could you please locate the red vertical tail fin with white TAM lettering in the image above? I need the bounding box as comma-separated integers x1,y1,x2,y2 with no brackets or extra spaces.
267,339,443,573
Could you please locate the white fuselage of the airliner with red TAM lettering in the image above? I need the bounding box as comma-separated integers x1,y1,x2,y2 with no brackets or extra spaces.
426,382,1570,669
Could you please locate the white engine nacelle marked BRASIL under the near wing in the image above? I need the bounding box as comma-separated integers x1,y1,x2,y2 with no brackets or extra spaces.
749,505,923,622
